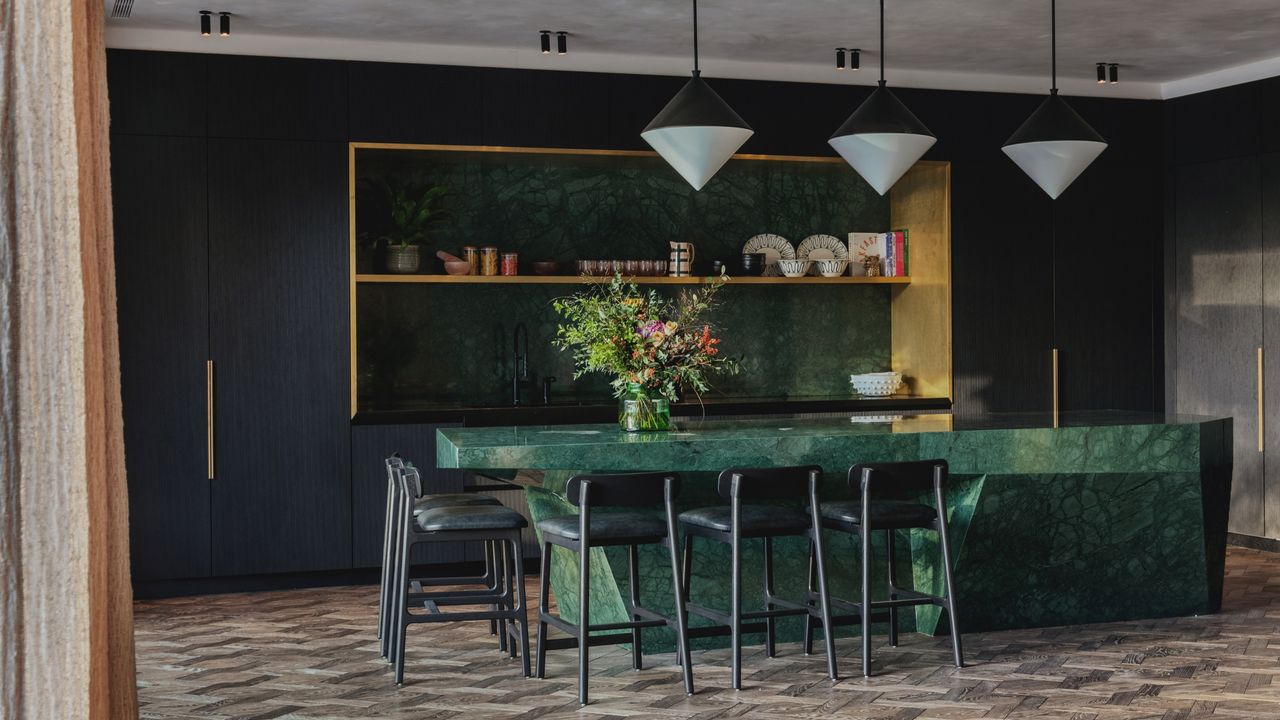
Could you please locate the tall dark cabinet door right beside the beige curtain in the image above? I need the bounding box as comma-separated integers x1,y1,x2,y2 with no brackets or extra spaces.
111,135,210,580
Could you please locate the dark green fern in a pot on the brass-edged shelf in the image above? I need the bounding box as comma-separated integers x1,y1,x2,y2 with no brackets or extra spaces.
369,176,449,273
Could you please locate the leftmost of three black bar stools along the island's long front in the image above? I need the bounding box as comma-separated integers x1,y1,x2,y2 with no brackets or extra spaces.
536,473,694,705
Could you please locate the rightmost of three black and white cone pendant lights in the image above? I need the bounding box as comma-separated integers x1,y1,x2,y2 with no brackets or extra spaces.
1002,0,1107,199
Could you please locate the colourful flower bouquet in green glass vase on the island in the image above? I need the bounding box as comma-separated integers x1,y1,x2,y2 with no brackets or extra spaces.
554,274,739,432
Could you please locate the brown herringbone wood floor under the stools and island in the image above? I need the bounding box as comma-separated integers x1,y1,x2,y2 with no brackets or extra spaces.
136,548,1280,720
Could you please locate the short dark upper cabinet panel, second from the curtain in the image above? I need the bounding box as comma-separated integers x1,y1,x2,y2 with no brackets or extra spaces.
209,55,350,142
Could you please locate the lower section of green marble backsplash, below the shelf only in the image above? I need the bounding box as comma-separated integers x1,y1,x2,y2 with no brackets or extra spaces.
357,279,890,409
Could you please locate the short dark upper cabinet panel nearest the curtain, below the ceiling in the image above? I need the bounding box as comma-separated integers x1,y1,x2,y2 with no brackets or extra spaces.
106,50,209,137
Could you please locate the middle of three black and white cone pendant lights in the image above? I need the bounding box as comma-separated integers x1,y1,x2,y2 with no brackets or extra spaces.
827,0,938,195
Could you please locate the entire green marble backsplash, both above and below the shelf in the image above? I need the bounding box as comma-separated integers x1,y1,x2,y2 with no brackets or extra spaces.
356,144,890,409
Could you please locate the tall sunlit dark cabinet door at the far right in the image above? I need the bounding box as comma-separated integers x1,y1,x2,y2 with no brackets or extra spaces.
1174,156,1263,536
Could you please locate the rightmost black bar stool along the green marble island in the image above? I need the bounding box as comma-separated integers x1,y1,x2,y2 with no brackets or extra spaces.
805,460,964,678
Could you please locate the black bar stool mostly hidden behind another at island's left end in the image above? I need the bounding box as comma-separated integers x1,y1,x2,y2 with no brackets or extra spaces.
378,452,507,661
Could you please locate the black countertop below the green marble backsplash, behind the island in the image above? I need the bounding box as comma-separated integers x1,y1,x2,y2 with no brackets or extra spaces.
351,395,951,427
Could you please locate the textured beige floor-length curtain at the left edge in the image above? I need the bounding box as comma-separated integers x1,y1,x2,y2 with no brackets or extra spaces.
0,0,137,720
